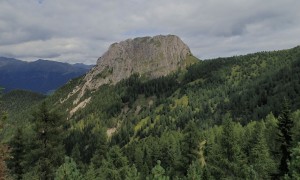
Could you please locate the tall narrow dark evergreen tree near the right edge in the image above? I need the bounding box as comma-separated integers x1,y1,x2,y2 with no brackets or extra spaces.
278,99,293,177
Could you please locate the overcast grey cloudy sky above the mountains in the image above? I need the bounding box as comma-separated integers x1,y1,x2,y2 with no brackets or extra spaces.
0,0,300,64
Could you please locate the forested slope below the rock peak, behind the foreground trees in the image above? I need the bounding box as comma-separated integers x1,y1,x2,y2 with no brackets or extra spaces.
49,47,300,131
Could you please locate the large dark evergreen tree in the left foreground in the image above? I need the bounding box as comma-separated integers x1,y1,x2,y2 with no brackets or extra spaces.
27,102,65,180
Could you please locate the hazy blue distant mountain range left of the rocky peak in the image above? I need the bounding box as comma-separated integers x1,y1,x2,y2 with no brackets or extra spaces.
0,57,93,94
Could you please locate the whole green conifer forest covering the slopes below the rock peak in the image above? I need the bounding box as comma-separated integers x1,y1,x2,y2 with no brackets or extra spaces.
0,47,300,180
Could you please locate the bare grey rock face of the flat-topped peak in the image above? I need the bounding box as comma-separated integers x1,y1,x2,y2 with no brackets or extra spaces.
66,35,191,108
